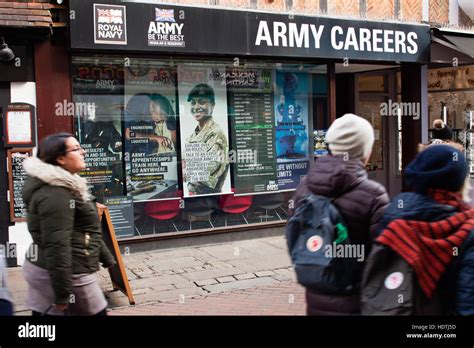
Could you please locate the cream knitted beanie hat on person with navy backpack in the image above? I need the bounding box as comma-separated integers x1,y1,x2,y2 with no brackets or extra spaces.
326,114,375,162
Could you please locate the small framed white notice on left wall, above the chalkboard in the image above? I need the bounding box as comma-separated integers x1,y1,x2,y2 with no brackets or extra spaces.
4,103,36,147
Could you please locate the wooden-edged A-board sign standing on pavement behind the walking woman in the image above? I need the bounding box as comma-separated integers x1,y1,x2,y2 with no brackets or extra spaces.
98,206,135,304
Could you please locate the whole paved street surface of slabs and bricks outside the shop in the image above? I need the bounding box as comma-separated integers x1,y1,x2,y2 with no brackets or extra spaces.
8,236,306,315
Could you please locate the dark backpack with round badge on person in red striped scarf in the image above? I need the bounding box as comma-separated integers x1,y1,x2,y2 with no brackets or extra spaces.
361,243,446,315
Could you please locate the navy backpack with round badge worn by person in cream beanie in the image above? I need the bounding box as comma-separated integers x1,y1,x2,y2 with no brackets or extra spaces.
285,193,363,294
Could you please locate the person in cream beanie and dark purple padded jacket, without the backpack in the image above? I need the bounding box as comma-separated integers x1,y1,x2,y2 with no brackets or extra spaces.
289,114,389,315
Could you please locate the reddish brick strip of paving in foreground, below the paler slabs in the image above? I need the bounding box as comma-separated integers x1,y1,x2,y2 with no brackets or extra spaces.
109,281,306,316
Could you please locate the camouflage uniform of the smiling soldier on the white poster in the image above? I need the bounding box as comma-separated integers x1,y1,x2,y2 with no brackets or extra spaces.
184,119,229,194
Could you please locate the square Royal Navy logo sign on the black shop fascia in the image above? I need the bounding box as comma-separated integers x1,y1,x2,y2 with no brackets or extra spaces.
94,4,127,45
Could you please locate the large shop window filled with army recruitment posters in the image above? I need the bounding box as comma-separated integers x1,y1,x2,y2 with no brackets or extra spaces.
72,56,327,237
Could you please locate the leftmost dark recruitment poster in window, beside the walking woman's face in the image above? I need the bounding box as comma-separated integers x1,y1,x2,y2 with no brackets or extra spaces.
71,61,124,203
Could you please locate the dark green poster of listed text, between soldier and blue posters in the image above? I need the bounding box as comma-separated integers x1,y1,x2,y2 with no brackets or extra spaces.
226,68,278,194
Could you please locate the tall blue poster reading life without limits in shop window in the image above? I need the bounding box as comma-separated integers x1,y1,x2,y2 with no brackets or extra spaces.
274,71,311,190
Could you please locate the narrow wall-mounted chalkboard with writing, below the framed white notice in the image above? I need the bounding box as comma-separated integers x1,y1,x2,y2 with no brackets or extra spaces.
7,149,31,222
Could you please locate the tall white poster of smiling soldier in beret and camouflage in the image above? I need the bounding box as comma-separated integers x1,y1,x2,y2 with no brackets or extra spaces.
178,64,231,197
